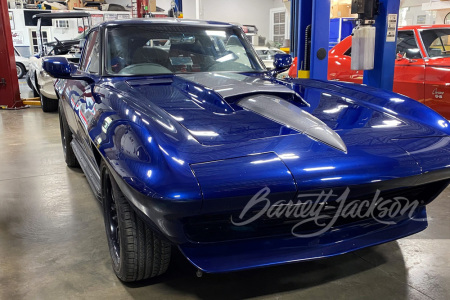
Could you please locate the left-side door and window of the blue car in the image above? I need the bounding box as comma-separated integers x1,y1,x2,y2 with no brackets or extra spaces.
65,30,101,162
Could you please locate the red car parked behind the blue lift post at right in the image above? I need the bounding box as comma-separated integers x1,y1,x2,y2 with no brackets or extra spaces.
290,25,450,119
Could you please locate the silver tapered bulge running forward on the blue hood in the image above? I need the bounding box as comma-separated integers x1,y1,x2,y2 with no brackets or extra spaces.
237,95,347,153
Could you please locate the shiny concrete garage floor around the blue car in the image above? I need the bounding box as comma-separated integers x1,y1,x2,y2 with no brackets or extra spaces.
0,81,450,299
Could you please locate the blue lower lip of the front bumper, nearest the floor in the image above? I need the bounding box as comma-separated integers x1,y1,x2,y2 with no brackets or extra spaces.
179,207,428,273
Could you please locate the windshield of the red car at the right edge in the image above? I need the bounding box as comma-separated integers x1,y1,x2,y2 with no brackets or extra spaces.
420,28,450,57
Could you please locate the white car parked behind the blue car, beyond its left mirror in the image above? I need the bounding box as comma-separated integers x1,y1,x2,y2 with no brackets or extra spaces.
27,12,90,112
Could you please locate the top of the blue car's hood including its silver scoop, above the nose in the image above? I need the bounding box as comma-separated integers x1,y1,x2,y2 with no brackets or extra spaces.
117,73,446,152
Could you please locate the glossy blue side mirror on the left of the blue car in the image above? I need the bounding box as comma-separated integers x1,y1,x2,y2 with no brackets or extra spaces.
42,56,94,84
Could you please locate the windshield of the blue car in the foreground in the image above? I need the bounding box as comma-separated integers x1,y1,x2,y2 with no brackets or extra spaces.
105,24,265,75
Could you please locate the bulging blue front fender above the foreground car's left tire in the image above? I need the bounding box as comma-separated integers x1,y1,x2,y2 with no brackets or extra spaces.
88,87,202,215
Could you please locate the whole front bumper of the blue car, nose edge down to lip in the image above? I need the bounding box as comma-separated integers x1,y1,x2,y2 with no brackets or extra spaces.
116,169,450,273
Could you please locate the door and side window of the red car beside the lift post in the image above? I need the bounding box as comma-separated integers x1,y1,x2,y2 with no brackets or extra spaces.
394,30,425,102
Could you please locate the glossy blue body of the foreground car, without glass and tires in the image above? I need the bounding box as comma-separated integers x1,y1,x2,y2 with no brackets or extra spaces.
46,20,450,273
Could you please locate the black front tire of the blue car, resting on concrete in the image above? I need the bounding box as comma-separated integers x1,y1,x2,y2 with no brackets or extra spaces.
100,162,171,282
